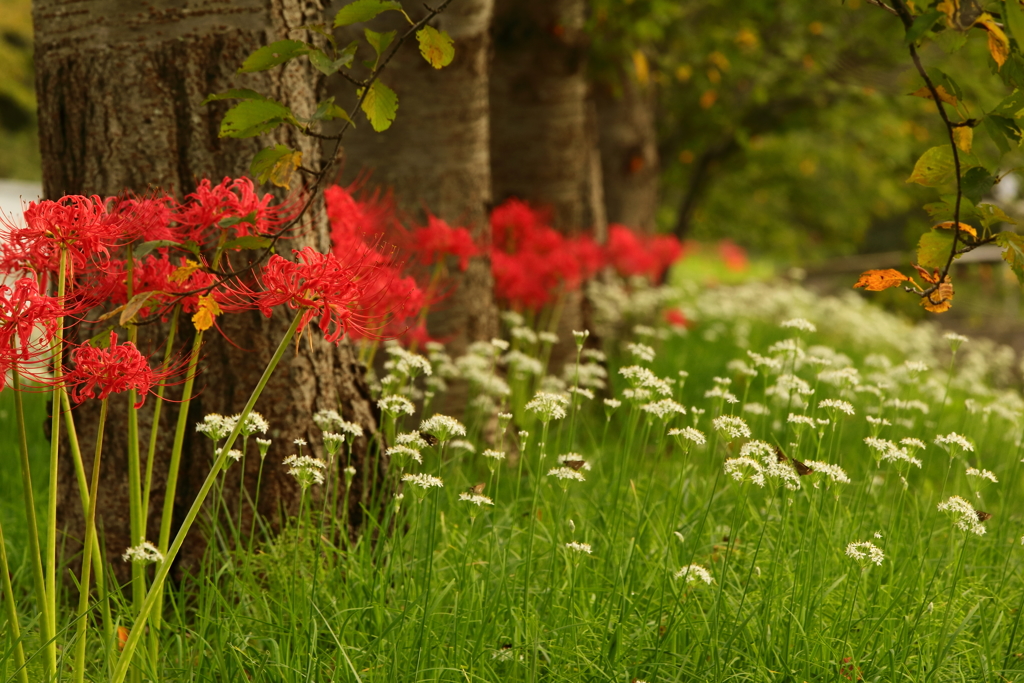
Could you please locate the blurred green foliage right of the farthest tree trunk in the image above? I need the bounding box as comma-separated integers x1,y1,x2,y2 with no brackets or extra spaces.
591,0,1019,262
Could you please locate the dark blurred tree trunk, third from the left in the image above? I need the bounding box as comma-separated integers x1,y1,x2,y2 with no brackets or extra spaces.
490,0,606,362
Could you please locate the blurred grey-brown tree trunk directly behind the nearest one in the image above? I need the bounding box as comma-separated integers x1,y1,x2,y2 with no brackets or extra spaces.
334,0,498,354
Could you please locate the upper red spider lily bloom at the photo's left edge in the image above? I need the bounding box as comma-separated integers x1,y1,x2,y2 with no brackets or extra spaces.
0,196,128,272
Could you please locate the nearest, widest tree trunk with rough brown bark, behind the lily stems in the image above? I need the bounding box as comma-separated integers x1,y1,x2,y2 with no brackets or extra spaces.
33,0,385,577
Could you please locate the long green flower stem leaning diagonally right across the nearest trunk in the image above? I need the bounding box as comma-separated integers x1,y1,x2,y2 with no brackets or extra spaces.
111,309,303,683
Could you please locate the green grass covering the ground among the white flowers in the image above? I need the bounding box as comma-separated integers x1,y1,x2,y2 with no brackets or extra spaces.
0,278,1024,683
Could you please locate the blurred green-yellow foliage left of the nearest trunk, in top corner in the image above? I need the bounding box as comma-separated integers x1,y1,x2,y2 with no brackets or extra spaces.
0,0,42,180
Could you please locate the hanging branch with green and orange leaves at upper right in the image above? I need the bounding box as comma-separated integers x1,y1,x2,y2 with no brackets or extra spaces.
854,0,1024,313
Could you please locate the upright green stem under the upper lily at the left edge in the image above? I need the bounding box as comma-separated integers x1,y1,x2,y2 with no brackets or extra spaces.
43,249,68,678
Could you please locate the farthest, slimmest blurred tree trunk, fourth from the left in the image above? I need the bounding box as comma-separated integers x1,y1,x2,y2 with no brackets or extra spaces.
595,74,658,234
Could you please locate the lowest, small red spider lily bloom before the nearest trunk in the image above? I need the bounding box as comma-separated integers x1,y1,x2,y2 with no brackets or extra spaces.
65,332,160,408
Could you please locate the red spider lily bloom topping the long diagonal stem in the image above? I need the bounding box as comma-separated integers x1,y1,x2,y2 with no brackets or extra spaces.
253,247,381,343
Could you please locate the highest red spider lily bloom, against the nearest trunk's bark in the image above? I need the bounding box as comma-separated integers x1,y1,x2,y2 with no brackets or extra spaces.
174,178,301,245
